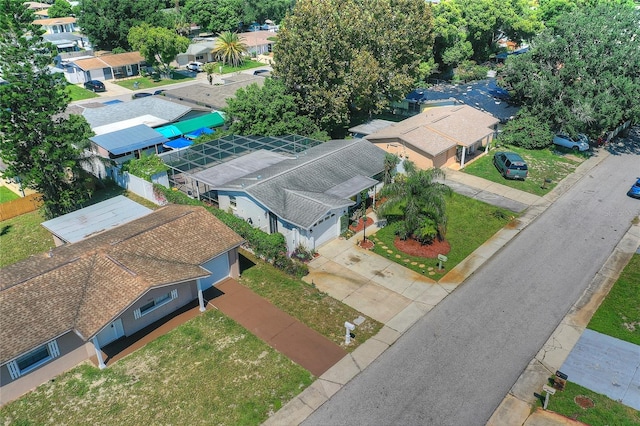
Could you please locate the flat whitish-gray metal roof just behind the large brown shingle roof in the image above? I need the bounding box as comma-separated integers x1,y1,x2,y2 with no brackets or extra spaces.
42,195,153,243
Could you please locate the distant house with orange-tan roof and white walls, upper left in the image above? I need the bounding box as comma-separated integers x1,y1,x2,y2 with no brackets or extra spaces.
72,52,145,83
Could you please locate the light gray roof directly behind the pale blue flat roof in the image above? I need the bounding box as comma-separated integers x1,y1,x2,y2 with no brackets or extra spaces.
82,96,191,128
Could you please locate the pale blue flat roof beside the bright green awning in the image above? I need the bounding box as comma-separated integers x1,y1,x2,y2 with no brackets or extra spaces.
90,124,168,155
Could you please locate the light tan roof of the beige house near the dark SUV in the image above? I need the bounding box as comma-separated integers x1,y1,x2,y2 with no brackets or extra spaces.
366,105,500,156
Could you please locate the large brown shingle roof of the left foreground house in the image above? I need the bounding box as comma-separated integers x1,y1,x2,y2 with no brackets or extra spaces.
0,205,243,364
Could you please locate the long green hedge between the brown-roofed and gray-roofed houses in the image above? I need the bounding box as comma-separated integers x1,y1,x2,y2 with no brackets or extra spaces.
154,185,309,277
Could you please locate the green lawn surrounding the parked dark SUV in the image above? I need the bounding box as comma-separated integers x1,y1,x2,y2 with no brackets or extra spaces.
462,145,588,196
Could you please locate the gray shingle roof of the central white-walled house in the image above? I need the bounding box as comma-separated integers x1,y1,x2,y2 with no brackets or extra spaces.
219,139,385,229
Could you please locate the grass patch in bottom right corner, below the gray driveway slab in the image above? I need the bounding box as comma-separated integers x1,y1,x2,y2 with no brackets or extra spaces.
539,382,640,426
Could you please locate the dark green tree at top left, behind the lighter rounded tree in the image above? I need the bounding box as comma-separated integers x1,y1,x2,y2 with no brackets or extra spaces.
78,0,171,51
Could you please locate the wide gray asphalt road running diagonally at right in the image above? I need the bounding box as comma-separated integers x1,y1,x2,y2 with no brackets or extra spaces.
303,144,640,426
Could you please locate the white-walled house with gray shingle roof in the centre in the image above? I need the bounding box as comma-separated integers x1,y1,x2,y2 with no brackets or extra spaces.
170,138,385,252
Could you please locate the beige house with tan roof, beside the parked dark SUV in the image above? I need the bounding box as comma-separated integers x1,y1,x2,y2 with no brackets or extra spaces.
366,105,500,169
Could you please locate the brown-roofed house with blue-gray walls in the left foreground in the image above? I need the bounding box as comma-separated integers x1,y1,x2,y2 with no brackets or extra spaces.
0,205,243,404
